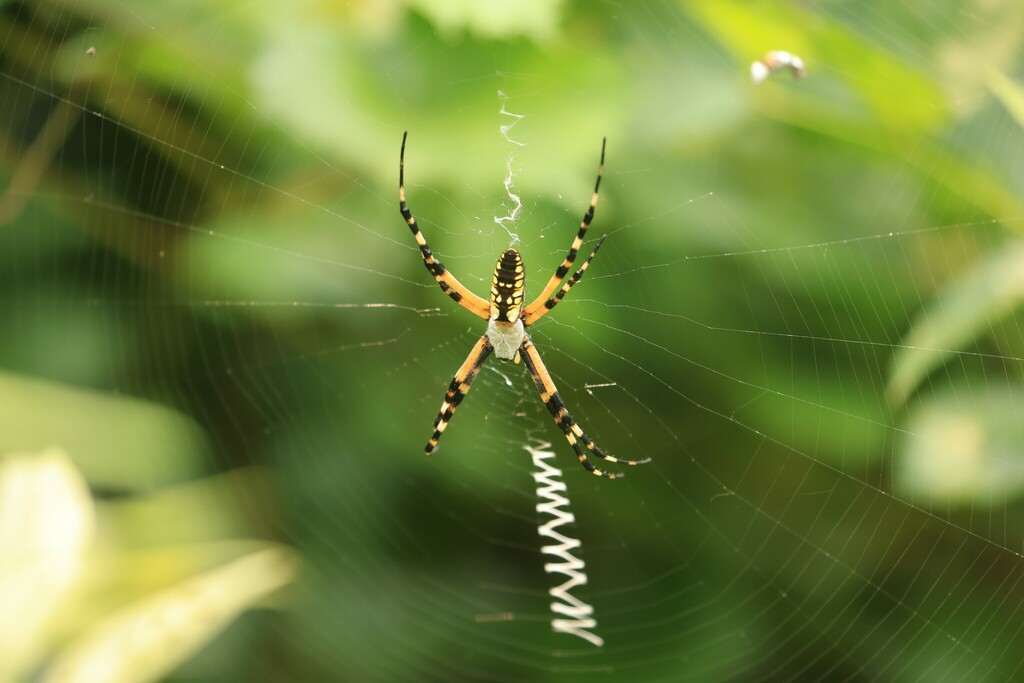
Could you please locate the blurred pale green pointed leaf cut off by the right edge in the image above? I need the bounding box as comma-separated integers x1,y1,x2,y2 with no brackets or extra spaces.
887,243,1024,405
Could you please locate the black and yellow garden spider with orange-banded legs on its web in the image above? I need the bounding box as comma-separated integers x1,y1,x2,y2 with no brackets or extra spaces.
398,131,650,479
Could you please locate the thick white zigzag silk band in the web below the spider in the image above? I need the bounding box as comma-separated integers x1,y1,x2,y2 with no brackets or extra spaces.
523,443,604,647
